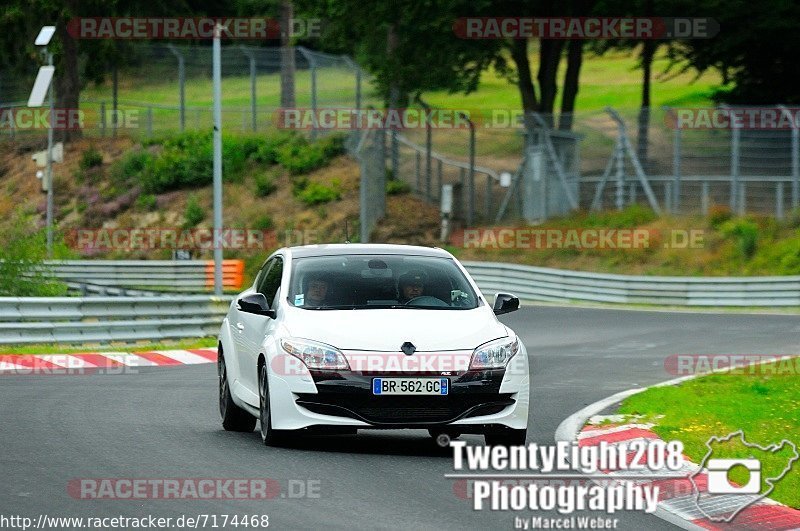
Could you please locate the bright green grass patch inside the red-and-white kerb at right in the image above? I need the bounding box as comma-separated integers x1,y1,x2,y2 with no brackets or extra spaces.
619,358,800,508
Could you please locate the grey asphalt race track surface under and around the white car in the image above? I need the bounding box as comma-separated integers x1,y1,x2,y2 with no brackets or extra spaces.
0,306,800,530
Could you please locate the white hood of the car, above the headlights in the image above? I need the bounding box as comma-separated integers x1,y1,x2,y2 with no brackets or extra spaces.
285,307,508,352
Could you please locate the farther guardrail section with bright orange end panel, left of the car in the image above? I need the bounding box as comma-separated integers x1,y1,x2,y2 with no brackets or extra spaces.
47,260,244,292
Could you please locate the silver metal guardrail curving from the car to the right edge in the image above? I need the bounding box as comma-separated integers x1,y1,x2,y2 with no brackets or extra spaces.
464,262,800,307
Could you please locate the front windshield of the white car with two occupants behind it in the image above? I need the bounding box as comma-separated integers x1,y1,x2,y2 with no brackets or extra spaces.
287,254,478,310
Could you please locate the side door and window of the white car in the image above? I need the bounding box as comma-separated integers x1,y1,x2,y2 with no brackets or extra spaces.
236,256,283,393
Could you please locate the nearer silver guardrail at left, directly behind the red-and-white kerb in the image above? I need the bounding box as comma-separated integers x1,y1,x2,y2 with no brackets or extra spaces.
0,295,232,344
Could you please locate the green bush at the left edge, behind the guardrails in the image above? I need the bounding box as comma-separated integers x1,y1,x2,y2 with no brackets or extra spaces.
0,214,67,297
